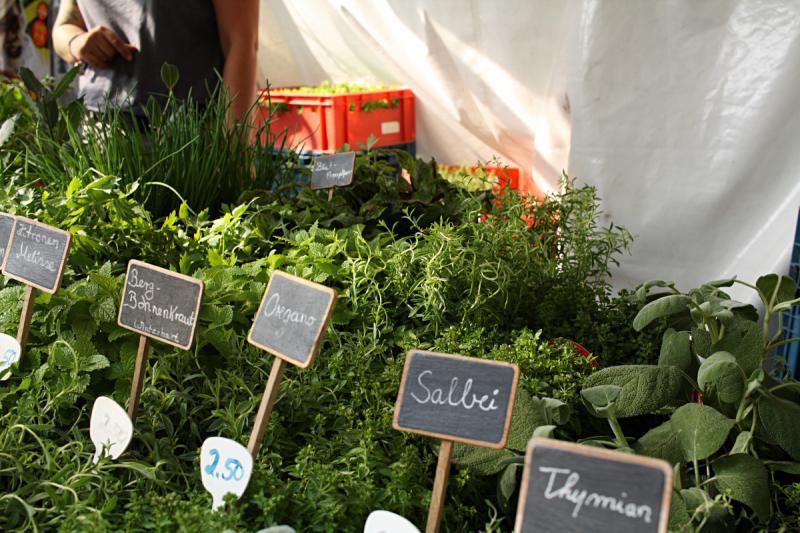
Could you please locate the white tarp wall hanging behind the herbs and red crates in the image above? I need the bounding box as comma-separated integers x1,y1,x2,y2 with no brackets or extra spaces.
259,0,800,296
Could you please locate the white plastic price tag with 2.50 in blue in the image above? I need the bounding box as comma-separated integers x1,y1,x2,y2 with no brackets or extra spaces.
200,437,253,510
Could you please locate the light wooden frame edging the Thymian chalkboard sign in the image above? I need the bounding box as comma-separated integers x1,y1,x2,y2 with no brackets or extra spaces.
514,437,673,533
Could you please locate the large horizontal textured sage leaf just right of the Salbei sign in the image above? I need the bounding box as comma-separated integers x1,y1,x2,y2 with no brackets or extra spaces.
584,365,689,418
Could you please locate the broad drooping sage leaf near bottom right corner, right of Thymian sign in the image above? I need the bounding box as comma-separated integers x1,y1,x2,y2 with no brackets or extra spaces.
712,453,770,522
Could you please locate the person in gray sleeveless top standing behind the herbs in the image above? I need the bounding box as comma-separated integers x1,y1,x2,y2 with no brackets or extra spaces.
53,0,259,120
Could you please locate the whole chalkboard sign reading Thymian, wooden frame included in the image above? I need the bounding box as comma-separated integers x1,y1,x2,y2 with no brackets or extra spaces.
514,438,672,533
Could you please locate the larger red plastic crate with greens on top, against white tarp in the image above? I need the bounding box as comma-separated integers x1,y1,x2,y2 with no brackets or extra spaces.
259,89,417,153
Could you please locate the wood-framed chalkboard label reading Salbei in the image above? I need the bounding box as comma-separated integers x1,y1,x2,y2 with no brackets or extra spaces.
394,350,519,448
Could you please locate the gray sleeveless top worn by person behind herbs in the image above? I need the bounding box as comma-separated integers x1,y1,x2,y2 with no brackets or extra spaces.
78,0,225,112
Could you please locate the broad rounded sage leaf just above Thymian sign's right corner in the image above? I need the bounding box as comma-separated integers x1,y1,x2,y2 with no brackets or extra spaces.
671,403,734,461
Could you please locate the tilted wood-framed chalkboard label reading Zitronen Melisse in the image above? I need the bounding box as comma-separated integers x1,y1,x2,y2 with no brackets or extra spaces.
3,217,72,294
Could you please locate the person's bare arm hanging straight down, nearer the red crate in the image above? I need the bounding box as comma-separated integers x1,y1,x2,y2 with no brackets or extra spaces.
214,0,259,121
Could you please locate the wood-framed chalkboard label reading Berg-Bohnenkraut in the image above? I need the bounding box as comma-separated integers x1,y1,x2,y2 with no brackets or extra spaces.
117,260,203,350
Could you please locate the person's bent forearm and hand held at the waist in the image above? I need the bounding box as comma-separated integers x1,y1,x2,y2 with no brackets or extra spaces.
53,0,137,69
